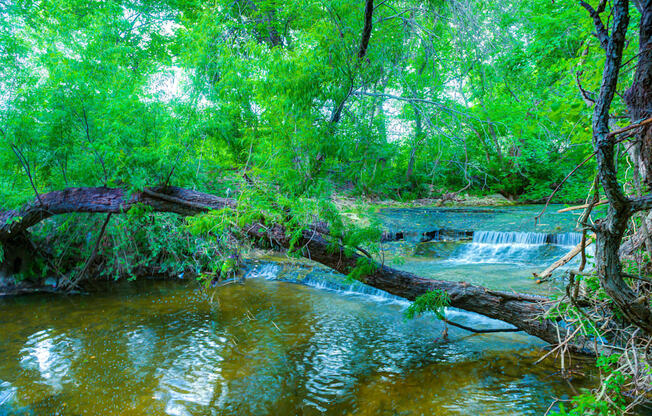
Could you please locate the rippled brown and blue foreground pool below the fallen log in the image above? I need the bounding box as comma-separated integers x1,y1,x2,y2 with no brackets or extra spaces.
0,268,592,416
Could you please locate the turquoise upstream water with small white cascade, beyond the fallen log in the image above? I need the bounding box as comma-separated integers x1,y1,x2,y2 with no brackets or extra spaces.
380,205,593,294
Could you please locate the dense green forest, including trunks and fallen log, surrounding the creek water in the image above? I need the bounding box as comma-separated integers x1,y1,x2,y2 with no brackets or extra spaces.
0,0,652,415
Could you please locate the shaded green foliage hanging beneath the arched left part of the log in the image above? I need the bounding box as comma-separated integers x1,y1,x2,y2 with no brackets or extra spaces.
33,211,233,279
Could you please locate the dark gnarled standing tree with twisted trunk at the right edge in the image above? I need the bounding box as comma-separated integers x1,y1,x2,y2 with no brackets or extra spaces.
582,0,652,335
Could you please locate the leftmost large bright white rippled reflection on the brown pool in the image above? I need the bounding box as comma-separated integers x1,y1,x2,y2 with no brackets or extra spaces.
20,329,82,391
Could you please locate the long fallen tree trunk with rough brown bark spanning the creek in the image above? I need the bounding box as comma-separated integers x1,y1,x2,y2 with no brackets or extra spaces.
0,187,580,350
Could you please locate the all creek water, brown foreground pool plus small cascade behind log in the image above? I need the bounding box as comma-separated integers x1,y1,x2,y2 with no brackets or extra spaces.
0,206,593,415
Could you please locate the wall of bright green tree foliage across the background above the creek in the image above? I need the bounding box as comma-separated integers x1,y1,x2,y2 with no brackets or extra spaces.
0,0,620,206
